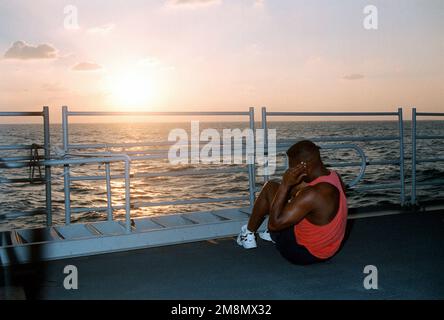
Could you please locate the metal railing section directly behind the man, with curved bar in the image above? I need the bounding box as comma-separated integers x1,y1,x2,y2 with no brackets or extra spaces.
262,107,405,205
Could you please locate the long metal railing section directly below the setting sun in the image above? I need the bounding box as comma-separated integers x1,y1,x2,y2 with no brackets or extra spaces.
62,106,255,223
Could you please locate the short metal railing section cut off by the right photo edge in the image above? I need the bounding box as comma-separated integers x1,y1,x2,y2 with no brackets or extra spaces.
410,108,444,205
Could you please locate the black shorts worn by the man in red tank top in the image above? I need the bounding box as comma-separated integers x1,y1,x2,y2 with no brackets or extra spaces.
270,227,328,265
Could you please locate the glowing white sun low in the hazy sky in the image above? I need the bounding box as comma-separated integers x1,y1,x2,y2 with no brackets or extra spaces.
107,72,155,111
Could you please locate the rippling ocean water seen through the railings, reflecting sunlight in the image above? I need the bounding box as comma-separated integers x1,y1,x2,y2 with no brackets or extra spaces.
0,121,444,230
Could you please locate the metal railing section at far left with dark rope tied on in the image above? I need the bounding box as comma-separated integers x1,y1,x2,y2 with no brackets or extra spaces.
0,106,52,226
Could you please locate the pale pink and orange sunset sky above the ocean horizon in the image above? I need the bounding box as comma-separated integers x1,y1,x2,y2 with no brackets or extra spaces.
0,0,444,122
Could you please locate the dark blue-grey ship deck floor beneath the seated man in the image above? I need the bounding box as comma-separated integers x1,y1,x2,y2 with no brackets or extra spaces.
2,209,444,300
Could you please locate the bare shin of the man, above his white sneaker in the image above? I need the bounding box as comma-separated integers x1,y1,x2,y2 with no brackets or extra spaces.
247,181,279,232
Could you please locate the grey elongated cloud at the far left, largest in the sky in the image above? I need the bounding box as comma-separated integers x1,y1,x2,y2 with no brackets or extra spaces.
4,41,57,60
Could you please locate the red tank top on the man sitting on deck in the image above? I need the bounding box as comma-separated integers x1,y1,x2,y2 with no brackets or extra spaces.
294,170,347,259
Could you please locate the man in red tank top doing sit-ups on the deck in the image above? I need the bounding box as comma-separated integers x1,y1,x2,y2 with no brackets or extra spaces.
237,140,347,265
